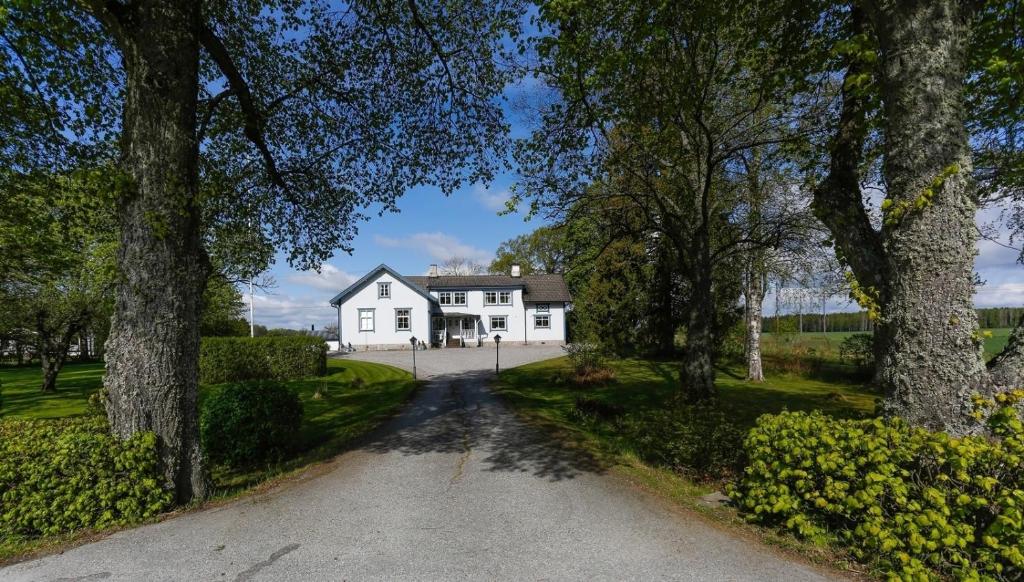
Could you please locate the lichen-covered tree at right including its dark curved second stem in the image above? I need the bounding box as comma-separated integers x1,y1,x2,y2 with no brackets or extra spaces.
814,0,1024,433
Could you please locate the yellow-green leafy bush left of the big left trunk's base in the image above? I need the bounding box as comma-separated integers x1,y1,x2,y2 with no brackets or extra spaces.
0,417,173,539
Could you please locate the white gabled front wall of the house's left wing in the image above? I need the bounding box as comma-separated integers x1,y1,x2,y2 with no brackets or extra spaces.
341,272,430,348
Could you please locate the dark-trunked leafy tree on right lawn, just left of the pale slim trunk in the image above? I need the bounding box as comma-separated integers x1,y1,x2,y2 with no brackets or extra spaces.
518,0,817,400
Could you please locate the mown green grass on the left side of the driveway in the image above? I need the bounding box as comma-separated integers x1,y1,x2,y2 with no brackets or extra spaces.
0,360,417,565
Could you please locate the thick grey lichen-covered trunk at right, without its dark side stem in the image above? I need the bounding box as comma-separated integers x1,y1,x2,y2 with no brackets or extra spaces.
869,0,986,433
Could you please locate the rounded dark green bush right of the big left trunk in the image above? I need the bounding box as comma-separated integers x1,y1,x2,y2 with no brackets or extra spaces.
200,380,302,467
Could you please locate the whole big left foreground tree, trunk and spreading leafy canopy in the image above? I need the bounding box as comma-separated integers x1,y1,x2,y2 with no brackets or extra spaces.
0,0,521,502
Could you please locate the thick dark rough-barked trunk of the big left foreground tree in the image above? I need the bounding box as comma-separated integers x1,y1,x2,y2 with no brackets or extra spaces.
105,0,209,503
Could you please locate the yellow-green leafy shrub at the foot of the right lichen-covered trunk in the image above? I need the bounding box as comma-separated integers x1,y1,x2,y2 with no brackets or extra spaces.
730,391,1024,580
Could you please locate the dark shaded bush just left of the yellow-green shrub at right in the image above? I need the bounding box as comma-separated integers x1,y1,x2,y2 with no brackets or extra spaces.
623,405,744,479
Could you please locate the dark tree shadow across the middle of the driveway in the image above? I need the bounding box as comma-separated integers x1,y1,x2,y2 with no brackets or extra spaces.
358,371,605,481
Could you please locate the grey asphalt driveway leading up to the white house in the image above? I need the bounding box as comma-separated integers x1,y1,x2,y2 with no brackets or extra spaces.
0,346,829,582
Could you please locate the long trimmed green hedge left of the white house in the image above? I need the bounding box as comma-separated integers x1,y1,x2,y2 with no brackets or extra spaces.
199,336,327,384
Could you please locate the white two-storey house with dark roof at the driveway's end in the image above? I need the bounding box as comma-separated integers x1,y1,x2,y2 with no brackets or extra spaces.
331,264,570,349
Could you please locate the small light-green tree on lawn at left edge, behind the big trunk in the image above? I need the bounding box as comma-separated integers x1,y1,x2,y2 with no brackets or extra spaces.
0,172,117,392
